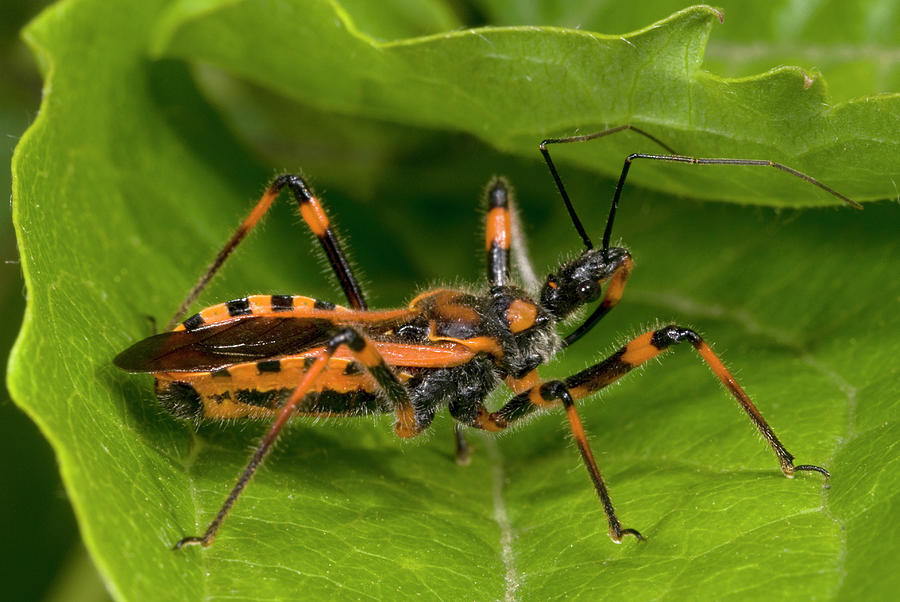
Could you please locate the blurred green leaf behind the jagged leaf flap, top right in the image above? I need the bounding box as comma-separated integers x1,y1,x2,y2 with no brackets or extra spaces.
482,0,900,100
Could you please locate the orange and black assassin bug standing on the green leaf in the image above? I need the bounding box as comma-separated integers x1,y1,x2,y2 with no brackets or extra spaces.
115,125,859,549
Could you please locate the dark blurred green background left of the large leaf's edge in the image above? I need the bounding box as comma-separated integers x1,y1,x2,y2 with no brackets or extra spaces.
0,1,93,600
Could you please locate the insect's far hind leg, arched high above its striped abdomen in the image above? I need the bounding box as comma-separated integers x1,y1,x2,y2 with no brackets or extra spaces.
166,174,366,330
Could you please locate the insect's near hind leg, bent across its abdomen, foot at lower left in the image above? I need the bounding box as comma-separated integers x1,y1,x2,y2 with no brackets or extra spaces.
174,328,419,550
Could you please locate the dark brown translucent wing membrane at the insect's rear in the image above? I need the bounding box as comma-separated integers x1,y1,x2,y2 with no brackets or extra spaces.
113,317,334,372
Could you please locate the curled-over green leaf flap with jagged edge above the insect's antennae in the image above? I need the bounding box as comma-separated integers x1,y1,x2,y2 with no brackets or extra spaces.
154,0,900,205
